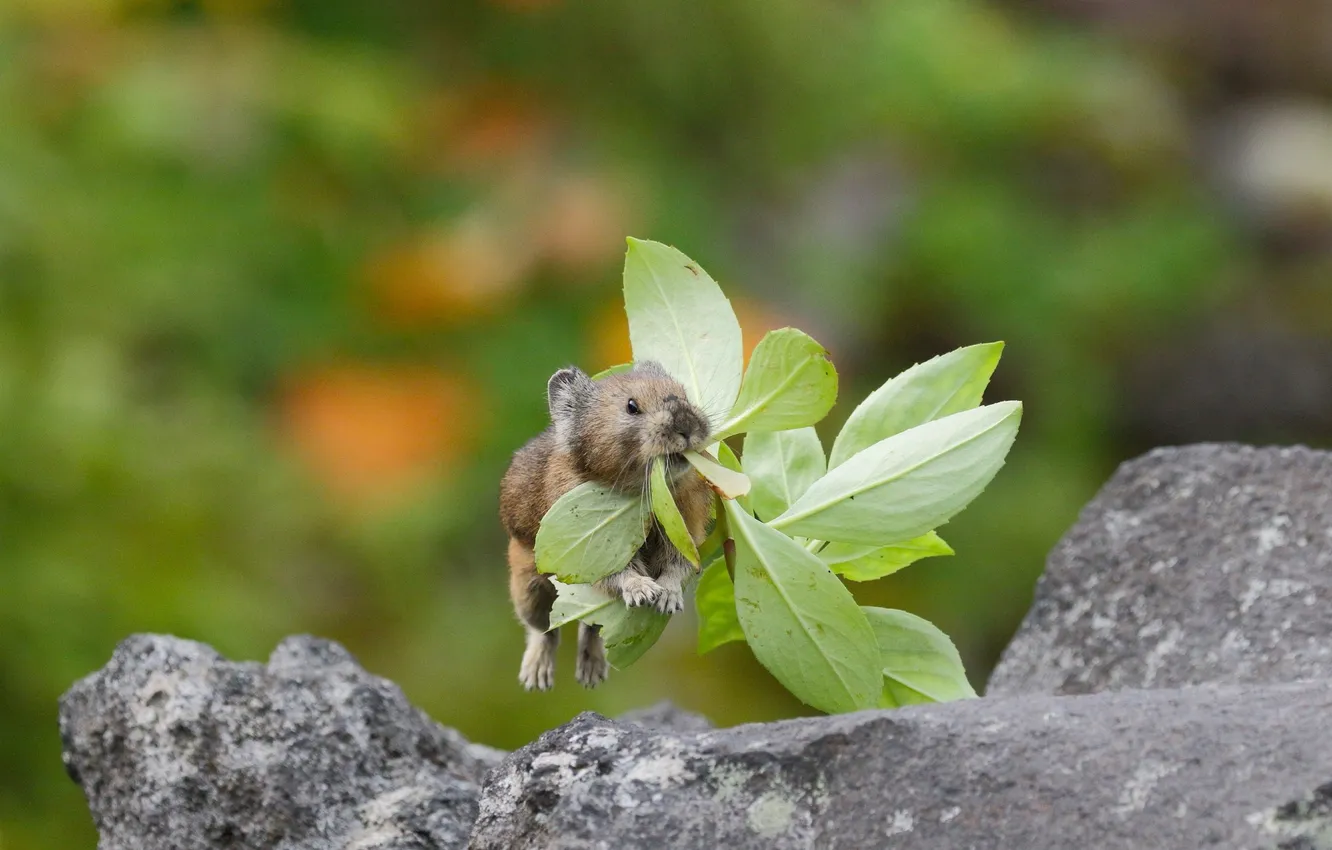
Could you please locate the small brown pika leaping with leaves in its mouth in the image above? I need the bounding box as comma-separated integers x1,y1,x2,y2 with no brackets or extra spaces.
500,361,713,690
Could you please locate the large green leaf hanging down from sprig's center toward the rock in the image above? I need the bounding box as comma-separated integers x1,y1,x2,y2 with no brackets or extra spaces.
725,502,883,713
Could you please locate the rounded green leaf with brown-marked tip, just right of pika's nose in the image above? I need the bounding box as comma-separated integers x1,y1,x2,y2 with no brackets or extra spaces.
717,328,836,438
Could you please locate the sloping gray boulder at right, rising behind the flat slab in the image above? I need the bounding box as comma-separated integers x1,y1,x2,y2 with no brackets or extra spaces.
988,445,1332,695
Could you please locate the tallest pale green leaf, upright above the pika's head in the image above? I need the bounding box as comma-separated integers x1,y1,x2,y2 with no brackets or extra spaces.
625,238,745,422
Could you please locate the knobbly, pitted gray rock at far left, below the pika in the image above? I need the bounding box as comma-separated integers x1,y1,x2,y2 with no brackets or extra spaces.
60,636,501,850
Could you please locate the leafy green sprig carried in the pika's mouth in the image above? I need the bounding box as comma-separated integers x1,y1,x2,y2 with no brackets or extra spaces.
537,238,1022,711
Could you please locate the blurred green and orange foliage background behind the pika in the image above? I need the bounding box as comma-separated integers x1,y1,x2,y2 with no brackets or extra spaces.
0,0,1332,850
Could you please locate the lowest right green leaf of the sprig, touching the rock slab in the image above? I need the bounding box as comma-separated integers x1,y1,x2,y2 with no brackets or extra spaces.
862,608,976,709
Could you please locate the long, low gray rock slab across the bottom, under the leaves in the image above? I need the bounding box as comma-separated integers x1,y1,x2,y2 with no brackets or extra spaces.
470,682,1332,850
